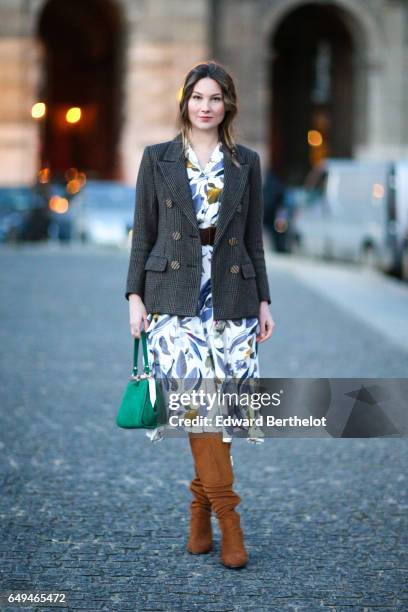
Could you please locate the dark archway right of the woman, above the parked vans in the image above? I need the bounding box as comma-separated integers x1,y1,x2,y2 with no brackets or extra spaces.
269,3,355,185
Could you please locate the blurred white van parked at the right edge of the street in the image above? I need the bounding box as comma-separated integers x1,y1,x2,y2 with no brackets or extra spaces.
294,159,407,273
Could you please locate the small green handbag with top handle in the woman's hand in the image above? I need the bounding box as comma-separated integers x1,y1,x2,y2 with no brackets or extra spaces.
116,331,167,429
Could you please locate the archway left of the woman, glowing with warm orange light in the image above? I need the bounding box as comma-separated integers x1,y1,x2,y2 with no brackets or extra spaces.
38,0,122,179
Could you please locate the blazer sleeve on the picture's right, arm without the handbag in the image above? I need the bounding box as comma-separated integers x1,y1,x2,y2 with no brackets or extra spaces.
245,151,271,304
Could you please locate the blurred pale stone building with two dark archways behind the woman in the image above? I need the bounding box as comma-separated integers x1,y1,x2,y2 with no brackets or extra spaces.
0,0,408,185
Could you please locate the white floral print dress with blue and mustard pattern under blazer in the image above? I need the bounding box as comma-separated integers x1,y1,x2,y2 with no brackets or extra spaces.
146,142,264,442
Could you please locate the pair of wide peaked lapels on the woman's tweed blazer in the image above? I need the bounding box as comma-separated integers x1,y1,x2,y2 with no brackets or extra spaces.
157,133,249,243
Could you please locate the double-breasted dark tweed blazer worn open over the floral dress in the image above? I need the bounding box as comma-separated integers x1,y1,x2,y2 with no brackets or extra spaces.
125,133,271,320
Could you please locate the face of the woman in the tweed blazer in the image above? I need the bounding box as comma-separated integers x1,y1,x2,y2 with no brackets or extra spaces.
188,77,225,130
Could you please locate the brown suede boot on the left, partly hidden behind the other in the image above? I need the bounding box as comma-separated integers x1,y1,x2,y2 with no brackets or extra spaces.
187,473,213,555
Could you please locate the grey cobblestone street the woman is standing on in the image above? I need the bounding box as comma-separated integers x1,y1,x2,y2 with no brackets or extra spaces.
0,246,408,612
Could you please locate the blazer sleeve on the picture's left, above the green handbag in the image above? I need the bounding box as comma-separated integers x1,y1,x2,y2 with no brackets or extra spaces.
125,146,158,300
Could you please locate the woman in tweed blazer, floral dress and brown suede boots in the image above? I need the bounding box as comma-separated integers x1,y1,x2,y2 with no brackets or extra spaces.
126,61,274,568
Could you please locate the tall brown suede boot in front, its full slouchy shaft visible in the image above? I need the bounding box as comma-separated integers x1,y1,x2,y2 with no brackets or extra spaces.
189,434,248,568
